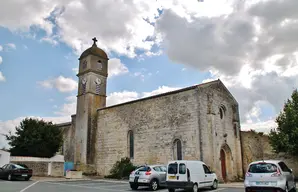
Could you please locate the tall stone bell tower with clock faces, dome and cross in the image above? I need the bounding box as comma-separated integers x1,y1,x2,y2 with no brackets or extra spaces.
74,38,109,165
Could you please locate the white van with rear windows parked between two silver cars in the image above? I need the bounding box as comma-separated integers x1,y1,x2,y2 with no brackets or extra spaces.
166,160,218,192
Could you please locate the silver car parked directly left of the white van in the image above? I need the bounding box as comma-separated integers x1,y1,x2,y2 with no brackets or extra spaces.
129,165,167,191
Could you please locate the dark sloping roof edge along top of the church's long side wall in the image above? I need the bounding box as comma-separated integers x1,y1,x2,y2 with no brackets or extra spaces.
97,79,223,111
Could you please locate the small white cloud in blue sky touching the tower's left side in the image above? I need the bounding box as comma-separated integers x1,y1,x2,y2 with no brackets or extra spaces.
38,76,78,92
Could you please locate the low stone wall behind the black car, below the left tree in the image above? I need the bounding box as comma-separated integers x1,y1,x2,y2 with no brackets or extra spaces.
10,155,64,177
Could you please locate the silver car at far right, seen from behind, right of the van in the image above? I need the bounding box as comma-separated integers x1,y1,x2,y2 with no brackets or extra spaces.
244,160,296,192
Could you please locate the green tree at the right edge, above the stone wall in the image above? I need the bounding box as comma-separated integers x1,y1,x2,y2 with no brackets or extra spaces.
269,90,298,156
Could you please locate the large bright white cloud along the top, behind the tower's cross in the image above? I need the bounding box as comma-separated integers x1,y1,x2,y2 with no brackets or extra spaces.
0,0,232,57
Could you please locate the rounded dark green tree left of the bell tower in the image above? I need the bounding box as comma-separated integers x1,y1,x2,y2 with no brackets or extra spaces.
5,118,63,158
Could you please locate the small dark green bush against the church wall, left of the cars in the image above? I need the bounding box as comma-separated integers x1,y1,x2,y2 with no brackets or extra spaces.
106,157,136,179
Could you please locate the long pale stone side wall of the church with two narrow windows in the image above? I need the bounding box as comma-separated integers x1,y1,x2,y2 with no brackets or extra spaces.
96,89,200,175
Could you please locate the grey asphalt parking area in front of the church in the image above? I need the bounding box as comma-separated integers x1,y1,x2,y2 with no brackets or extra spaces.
0,180,243,192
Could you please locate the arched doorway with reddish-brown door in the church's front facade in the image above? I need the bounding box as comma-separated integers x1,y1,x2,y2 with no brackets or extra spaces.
220,143,233,182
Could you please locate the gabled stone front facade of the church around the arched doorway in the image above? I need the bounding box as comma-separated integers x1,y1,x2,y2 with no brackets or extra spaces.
198,83,243,181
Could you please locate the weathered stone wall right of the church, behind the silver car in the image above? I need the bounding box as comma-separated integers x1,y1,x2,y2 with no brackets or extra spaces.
241,131,298,177
